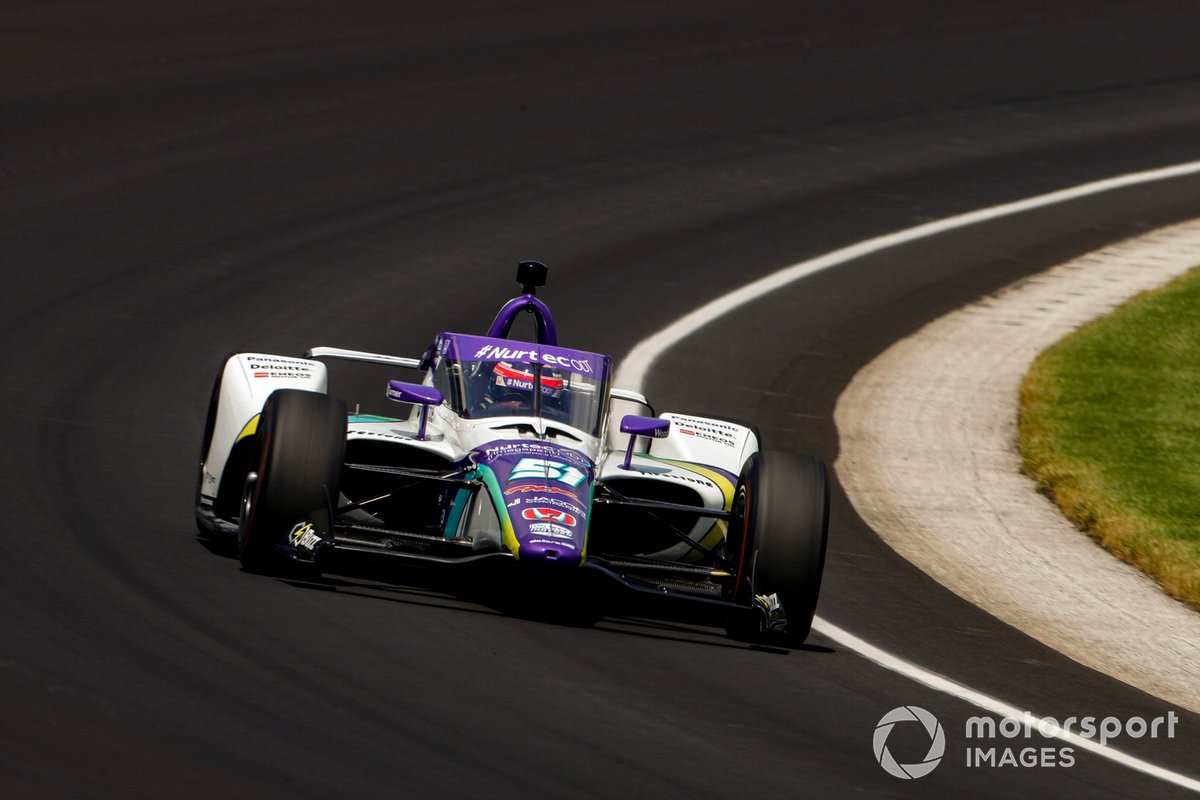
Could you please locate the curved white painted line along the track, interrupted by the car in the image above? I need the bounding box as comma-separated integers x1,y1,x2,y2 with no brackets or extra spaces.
614,161,1200,792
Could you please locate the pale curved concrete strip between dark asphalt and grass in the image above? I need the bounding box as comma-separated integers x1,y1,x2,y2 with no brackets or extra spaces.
834,221,1200,712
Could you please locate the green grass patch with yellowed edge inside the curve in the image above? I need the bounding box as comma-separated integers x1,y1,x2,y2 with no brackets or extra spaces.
1020,269,1200,608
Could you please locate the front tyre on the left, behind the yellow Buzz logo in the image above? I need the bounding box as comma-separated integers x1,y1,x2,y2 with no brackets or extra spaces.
238,389,346,573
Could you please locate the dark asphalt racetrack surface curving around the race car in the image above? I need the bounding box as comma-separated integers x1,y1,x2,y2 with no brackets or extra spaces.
0,0,1200,798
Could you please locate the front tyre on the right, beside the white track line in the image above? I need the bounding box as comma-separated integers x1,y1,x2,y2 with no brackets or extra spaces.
730,451,829,645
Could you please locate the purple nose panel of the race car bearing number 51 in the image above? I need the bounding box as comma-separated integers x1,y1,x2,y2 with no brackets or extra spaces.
470,439,595,565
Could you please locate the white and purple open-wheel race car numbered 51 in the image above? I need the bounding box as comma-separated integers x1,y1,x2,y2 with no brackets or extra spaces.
196,261,829,644
